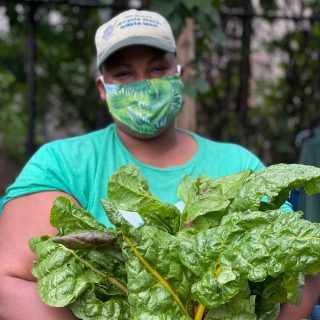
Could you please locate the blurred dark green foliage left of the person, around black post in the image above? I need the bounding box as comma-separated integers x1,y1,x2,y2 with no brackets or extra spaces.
0,2,111,165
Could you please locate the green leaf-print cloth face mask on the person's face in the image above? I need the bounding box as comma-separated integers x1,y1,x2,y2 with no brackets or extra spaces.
102,75,182,135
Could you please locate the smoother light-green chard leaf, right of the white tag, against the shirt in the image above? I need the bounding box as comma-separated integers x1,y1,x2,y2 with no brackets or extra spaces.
180,170,252,226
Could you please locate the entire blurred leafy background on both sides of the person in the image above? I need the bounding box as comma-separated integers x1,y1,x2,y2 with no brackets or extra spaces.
0,0,320,194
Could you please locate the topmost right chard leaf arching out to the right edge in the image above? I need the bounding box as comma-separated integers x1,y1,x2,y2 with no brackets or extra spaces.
229,164,320,212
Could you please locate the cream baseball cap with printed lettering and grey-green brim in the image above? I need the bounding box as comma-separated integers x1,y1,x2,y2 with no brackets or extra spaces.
95,9,176,68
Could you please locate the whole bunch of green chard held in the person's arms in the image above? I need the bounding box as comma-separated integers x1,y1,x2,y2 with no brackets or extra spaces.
30,164,320,320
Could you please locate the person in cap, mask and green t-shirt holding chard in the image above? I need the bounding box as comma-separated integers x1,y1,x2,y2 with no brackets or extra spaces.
0,9,320,320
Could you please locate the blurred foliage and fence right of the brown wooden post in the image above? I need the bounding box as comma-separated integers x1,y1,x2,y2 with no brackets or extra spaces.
174,0,320,165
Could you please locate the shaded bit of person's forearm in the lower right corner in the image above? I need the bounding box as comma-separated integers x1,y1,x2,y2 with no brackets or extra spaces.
278,274,320,320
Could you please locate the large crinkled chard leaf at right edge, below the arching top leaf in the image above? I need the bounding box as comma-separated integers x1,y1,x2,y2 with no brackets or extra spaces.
220,210,320,281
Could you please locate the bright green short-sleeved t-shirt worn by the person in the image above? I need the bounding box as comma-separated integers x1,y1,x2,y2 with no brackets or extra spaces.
3,124,270,226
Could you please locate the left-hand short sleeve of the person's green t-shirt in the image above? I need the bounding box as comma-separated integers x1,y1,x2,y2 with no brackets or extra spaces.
2,143,75,210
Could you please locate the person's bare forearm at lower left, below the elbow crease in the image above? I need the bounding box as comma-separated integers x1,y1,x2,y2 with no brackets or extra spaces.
0,277,77,320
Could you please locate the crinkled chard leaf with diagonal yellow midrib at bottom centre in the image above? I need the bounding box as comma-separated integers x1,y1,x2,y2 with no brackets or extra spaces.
122,226,191,319
